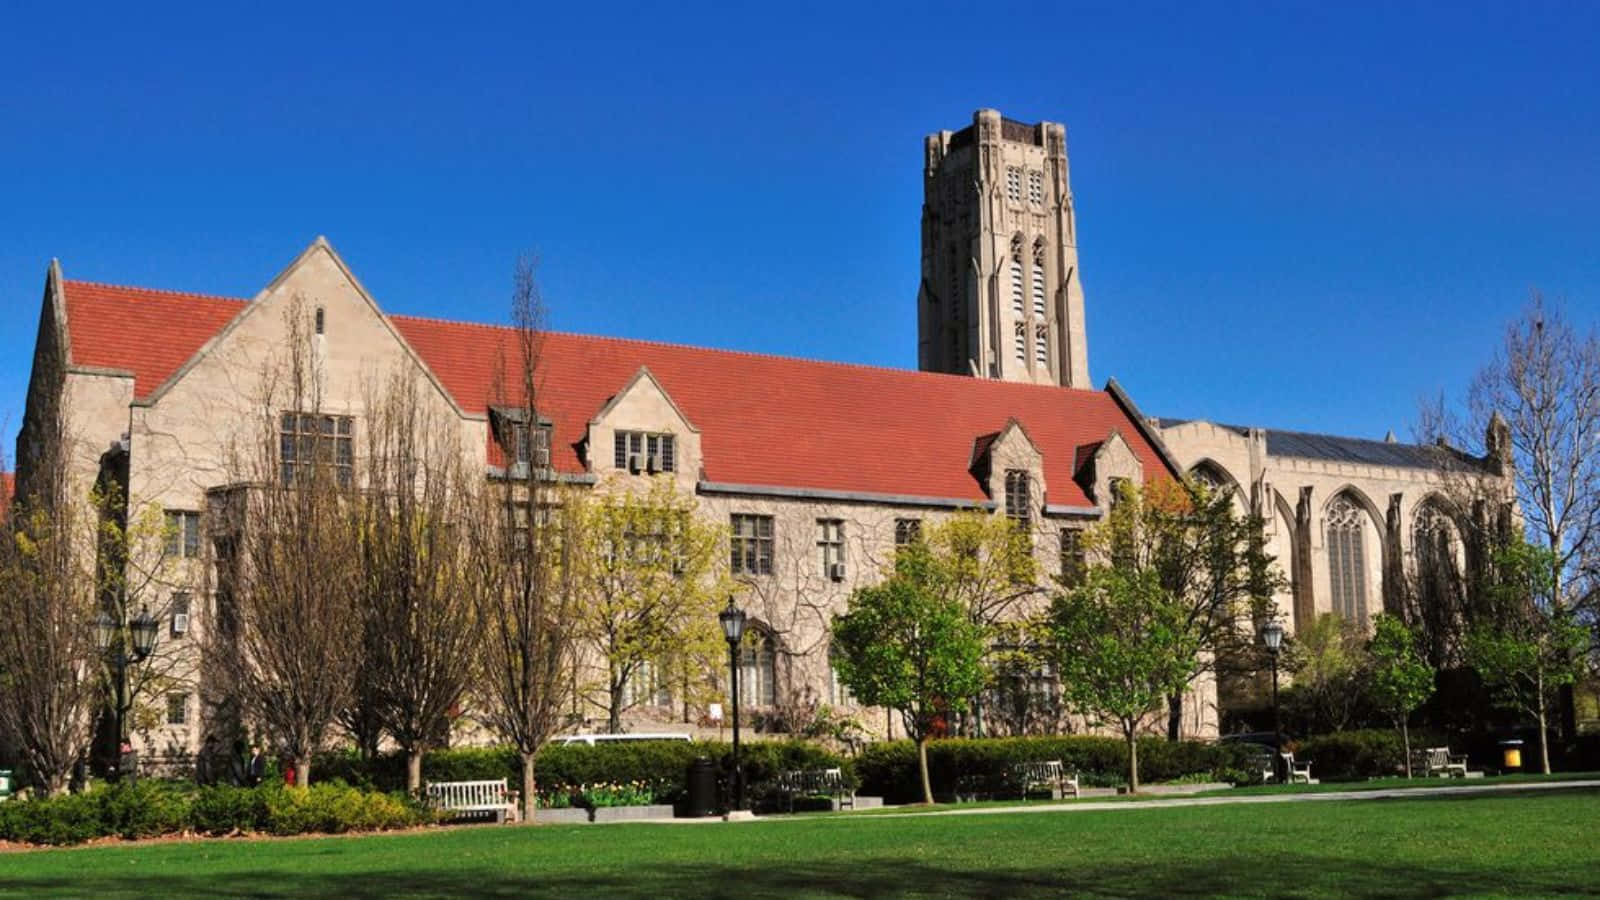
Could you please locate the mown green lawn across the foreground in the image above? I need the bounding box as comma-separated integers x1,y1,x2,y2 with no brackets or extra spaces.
0,791,1600,897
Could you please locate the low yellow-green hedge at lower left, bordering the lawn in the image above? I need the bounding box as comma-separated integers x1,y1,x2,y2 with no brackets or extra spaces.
0,778,432,844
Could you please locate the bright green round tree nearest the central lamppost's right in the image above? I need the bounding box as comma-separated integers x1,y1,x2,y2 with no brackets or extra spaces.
834,546,984,804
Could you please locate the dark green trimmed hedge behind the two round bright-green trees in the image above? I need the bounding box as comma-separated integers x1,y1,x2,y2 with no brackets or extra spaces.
856,735,1250,802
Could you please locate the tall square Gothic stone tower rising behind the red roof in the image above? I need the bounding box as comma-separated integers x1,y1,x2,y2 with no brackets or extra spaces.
917,109,1090,388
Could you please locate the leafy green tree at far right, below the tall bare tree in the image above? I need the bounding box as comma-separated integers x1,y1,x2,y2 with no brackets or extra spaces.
1467,541,1589,773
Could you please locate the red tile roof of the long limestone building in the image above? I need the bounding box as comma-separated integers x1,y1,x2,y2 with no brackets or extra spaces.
66,282,1168,506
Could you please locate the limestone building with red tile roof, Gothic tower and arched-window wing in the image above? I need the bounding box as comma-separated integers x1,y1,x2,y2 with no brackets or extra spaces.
16,110,1509,757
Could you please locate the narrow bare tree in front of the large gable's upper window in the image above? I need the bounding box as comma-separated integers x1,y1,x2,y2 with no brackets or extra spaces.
208,298,362,785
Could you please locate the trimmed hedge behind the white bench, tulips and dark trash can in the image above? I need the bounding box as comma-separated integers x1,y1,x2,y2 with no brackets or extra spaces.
312,740,850,802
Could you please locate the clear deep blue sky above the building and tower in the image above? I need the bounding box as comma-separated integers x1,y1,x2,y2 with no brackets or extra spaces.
0,3,1600,455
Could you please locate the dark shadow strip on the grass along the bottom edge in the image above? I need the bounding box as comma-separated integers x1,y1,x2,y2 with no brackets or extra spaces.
0,852,1595,897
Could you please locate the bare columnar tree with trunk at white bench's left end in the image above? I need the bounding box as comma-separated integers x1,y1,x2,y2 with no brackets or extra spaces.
361,372,478,793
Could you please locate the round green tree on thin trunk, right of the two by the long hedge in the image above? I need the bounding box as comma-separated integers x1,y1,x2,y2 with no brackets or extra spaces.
1050,565,1200,793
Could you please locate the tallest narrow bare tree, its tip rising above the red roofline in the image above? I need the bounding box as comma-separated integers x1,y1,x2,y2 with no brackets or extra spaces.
467,258,578,822
